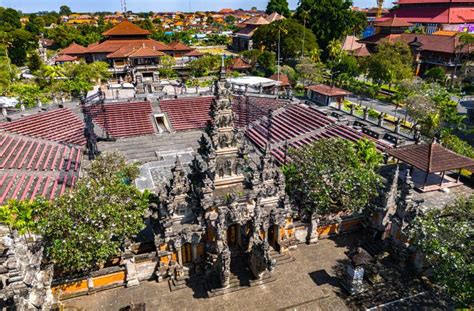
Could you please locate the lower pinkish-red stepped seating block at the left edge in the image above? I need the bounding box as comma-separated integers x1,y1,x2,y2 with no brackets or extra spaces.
0,132,82,205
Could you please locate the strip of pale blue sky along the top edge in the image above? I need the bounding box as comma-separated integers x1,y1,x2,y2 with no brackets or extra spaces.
0,0,389,13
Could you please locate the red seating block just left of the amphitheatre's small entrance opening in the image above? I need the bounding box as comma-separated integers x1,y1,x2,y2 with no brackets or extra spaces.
86,102,155,138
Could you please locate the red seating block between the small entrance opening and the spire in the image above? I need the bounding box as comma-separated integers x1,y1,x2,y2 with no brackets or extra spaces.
159,96,214,131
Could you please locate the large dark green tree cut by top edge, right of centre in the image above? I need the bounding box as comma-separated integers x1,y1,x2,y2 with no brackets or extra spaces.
295,0,367,58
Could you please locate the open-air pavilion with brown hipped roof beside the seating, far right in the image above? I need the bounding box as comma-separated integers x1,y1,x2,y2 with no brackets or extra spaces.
386,142,474,192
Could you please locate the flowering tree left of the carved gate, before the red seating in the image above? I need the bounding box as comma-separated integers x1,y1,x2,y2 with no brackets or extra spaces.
34,153,148,272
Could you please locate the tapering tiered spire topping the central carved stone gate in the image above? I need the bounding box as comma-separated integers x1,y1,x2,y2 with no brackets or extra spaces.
208,59,244,189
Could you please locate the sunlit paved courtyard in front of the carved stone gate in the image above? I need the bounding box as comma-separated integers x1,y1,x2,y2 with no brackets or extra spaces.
64,235,355,311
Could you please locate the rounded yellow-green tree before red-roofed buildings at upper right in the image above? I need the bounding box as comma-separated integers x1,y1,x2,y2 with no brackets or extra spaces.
366,42,413,85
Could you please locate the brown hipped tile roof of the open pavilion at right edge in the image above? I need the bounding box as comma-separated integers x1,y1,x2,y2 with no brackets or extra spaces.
386,143,474,173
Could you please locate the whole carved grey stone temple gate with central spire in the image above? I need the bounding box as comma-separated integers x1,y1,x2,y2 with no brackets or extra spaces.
152,62,297,288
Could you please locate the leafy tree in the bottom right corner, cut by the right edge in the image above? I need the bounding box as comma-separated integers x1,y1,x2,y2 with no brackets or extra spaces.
409,196,474,308
